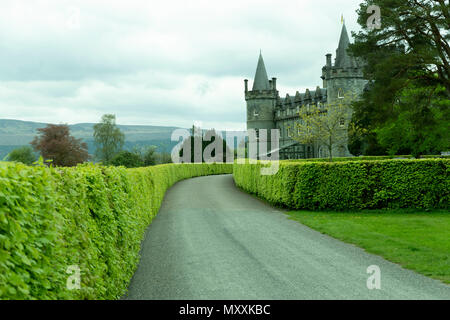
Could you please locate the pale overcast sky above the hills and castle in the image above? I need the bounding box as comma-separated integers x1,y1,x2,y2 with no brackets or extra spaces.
0,0,361,129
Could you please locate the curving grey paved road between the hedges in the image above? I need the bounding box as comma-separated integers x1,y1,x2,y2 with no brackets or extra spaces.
126,175,450,299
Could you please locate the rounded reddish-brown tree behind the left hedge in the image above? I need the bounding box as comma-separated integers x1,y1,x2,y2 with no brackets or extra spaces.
31,124,89,167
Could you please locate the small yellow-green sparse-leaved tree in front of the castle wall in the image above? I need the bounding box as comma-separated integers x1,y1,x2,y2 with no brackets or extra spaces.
288,94,352,161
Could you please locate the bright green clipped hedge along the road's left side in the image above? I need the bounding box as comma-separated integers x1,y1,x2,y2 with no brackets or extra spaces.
0,163,232,300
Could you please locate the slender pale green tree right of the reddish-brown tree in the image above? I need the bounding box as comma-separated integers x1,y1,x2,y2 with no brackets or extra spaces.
94,114,125,164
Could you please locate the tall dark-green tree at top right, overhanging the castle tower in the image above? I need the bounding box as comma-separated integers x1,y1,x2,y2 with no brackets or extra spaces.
350,0,450,97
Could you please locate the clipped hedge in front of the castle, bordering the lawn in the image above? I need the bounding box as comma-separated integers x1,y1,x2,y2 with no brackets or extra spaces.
233,159,450,210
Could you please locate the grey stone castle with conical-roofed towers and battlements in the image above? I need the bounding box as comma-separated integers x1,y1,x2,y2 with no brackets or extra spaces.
244,24,367,159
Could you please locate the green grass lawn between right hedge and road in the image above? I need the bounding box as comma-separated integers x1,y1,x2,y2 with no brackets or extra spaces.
288,210,450,284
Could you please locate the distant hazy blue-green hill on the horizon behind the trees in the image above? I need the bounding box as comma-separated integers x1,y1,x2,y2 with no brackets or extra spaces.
0,119,244,161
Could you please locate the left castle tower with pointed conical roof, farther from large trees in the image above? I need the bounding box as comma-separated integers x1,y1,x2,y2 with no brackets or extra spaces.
244,53,278,151
